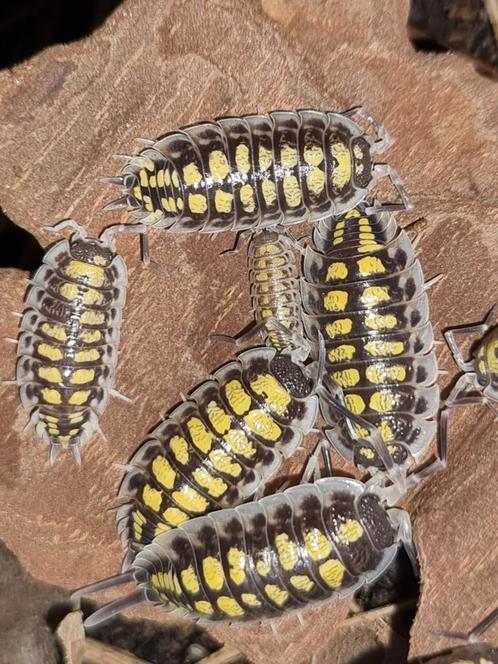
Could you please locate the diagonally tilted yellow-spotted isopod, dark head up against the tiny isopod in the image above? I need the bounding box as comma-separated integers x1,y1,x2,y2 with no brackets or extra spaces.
117,348,318,558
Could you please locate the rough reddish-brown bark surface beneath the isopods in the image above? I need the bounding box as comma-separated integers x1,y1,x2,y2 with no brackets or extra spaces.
0,0,498,664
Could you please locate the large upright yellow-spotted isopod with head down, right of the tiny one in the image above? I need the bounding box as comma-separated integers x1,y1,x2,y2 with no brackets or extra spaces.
301,204,439,470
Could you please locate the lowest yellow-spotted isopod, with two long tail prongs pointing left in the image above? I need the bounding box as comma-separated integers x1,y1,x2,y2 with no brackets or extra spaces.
76,478,410,627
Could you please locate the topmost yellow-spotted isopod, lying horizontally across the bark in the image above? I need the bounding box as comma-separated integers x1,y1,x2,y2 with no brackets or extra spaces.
105,108,411,260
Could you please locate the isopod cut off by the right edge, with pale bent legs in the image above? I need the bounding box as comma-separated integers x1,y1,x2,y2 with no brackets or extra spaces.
439,304,498,474
